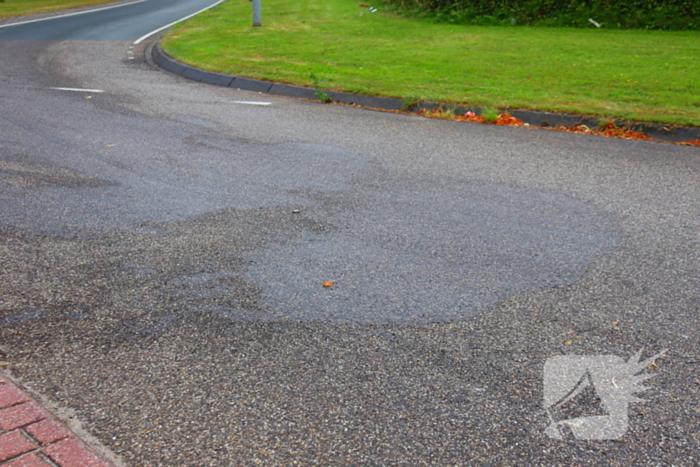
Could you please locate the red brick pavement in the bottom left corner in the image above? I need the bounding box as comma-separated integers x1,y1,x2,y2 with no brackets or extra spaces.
0,376,114,467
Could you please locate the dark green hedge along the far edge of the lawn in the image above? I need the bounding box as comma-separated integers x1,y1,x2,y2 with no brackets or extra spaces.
384,0,700,30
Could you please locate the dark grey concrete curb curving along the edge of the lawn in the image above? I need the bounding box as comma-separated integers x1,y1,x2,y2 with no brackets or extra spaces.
146,42,700,142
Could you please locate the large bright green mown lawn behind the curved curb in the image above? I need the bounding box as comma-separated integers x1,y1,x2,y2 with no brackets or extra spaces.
163,0,700,126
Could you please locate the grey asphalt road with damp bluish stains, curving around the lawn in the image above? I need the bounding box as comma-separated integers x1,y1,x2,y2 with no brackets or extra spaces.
0,0,700,467
